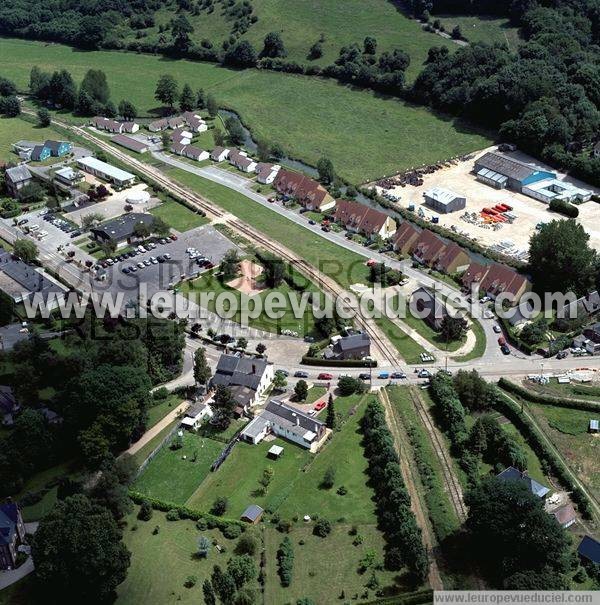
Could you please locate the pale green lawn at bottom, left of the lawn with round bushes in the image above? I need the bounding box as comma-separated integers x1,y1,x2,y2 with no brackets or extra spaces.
116,506,258,605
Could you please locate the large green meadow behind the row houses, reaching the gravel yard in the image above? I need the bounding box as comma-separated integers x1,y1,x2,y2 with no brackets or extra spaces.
0,38,490,183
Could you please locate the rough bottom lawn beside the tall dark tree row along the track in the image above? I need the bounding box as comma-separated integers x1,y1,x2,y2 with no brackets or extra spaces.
265,521,414,605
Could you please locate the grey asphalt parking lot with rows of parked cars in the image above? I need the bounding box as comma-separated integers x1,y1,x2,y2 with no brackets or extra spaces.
96,225,237,302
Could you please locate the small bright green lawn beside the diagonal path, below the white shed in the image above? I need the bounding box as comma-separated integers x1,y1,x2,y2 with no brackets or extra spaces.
132,431,223,504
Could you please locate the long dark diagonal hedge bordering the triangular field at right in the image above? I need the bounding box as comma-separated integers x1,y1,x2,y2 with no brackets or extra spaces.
495,393,592,519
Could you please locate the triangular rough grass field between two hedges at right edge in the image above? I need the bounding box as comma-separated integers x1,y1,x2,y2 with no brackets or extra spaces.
526,402,600,500
